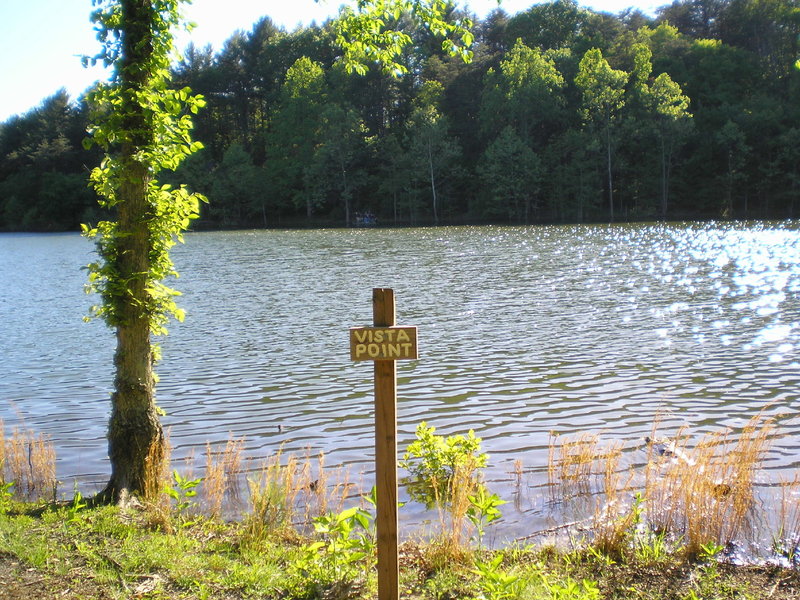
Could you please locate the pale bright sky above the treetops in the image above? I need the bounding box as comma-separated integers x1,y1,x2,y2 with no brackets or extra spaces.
0,0,669,122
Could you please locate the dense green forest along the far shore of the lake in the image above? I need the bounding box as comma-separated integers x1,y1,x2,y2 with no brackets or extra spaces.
0,0,800,231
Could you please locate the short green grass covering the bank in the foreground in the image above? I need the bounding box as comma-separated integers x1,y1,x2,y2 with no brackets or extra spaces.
0,507,800,600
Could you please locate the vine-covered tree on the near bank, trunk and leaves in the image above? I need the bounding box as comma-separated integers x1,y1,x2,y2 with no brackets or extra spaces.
84,0,203,501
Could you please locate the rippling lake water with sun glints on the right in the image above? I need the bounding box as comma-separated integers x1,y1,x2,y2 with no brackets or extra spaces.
0,222,800,537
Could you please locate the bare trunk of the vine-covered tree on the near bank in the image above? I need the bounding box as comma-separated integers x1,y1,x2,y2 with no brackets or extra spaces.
99,0,165,502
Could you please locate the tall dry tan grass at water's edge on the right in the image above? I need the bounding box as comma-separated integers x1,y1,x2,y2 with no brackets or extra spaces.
548,411,780,556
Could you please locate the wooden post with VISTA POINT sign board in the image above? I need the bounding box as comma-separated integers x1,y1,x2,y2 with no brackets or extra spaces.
350,288,417,600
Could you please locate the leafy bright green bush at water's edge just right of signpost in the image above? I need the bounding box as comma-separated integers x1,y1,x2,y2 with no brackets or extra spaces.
400,421,489,507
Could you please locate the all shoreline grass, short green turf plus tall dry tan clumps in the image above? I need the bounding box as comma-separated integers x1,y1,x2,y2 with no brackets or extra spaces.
0,414,800,600
